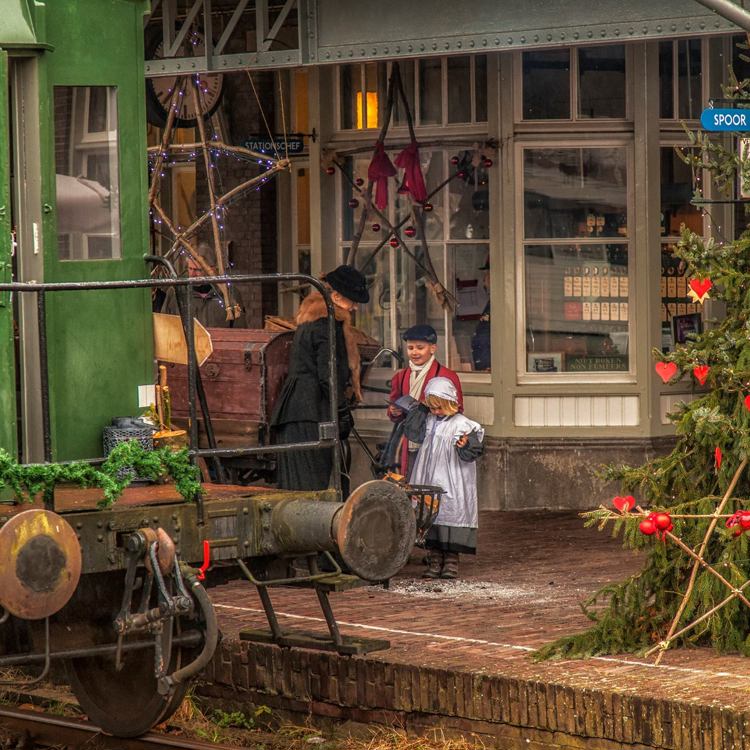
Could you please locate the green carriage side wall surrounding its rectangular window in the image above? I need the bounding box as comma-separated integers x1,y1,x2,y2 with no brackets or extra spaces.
37,0,153,460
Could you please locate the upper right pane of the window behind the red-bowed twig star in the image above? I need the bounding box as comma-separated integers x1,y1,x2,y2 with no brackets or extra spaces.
448,151,490,240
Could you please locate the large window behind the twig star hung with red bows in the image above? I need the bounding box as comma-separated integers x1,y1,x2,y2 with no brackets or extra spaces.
341,149,490,372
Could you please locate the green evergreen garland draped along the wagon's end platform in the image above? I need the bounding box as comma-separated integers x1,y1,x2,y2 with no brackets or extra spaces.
0,440,202,508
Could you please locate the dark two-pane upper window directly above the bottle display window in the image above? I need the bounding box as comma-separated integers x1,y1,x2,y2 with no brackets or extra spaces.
520,44,627,120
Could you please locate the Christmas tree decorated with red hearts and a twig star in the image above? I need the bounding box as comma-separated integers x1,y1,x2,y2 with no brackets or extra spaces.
538,70,750,662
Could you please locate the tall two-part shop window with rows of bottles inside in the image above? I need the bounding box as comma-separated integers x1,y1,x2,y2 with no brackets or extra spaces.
523,147,631,374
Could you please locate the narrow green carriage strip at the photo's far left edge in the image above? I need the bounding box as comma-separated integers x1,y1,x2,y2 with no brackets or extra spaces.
0,49,16,455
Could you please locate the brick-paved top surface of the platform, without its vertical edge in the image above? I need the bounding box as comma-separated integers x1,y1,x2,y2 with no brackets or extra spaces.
207,512,750,712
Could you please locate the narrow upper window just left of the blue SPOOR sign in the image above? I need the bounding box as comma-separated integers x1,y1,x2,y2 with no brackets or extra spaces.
659,39,703,120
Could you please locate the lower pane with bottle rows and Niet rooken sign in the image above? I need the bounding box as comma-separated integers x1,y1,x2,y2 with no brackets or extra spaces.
524,244,630,373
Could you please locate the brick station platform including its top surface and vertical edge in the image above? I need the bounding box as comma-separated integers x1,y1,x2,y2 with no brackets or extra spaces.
201,512,750,750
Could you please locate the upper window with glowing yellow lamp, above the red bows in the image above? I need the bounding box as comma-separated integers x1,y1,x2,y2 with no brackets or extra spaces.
338,55,487,130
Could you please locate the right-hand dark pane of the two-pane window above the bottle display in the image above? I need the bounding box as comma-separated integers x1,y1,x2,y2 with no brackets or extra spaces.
578,44,625,118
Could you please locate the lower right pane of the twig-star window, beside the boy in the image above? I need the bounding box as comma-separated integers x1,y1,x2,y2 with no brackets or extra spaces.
449,244,490,372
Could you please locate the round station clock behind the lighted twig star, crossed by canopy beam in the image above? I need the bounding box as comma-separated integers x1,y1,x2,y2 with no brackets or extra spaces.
146,34,224,127
